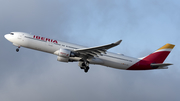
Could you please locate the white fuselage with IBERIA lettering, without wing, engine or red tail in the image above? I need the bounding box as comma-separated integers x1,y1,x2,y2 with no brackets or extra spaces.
5,32,140,69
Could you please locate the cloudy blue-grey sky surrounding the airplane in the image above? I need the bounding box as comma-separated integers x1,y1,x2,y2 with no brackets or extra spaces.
0,0,180,101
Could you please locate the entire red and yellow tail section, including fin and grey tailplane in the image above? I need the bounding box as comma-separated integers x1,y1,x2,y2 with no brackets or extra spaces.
127,43,175,70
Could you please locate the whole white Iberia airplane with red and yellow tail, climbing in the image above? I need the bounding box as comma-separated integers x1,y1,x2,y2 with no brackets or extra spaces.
4,32,175,73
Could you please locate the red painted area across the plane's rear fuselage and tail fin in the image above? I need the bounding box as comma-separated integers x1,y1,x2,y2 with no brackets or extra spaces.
127,51,170,70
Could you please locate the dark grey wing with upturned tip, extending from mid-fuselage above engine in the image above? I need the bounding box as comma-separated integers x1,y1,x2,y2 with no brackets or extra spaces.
74,40,122,57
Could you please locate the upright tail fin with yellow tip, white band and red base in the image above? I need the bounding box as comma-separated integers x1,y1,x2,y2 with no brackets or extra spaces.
142,43,175,63
